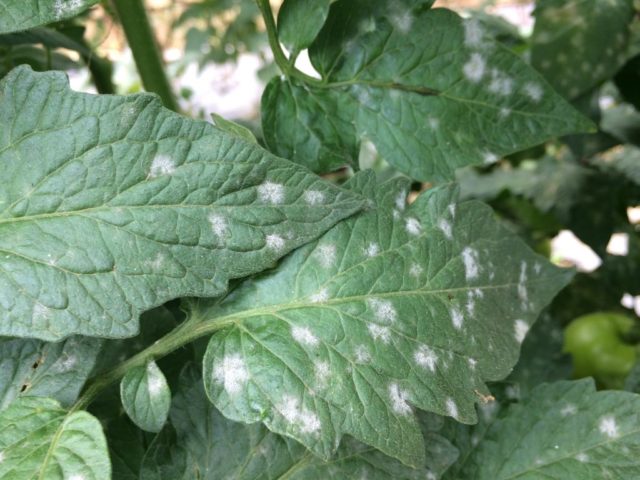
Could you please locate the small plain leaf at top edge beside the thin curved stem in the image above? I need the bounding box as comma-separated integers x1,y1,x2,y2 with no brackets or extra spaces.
278,0,331,52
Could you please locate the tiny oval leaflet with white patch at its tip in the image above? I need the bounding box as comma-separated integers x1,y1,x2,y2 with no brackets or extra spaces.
120,362,171,432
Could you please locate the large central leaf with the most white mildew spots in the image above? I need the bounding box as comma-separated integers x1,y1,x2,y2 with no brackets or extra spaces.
192,174,571,465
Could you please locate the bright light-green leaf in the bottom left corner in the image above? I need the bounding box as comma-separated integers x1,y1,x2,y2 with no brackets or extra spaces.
0,397,111,480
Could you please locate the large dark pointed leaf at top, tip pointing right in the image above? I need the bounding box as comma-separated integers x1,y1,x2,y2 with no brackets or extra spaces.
262,0,591,180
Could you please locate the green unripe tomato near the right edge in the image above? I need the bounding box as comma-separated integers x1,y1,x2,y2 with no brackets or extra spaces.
564,312,638,388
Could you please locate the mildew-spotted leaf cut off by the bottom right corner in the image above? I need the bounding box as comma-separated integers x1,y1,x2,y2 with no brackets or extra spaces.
452,379,640,480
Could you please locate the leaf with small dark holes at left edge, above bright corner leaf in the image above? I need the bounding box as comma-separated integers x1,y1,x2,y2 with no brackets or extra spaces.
0,336,102,410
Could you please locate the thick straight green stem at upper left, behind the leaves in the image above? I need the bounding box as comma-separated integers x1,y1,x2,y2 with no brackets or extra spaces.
113,0,178,111
